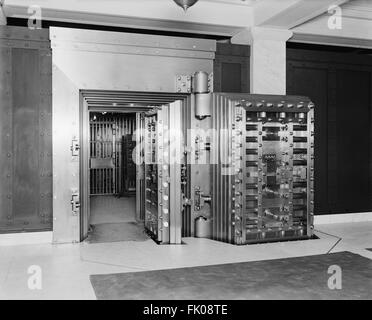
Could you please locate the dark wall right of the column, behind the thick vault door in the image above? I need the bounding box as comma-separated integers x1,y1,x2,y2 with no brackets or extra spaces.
287,48,372,214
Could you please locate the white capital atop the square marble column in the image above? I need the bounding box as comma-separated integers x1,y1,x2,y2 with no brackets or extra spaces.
231,27,293,45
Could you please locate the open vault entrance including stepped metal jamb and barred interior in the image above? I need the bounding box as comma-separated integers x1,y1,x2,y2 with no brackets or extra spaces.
80,91,187,240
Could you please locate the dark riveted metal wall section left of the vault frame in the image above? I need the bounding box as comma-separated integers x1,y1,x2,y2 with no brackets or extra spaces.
0,27,52,232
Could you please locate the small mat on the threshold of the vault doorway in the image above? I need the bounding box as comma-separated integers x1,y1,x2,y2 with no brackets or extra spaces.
86,222,149,243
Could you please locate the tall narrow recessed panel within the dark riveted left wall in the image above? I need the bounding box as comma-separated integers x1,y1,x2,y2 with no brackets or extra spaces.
12,48,40,224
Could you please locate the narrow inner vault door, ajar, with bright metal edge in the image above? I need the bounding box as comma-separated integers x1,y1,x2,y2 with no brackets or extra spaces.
143,101,183,244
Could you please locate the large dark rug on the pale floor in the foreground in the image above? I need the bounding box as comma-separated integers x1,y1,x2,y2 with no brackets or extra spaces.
90,252,372,300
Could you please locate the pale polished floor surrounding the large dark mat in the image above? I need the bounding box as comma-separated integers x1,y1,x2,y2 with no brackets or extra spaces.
0,222,372,299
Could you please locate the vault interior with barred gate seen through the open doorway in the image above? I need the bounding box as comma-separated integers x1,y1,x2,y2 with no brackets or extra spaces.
89,111,136,225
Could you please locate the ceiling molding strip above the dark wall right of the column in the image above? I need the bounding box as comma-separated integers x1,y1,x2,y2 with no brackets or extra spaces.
289,32,372,49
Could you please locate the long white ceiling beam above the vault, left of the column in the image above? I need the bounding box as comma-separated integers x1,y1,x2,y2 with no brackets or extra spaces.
4,0,256,28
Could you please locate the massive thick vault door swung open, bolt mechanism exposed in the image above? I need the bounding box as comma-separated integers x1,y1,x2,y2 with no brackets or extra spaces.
211,93,314,244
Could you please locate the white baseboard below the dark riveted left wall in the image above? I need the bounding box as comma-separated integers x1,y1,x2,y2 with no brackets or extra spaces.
0,231,53,246
